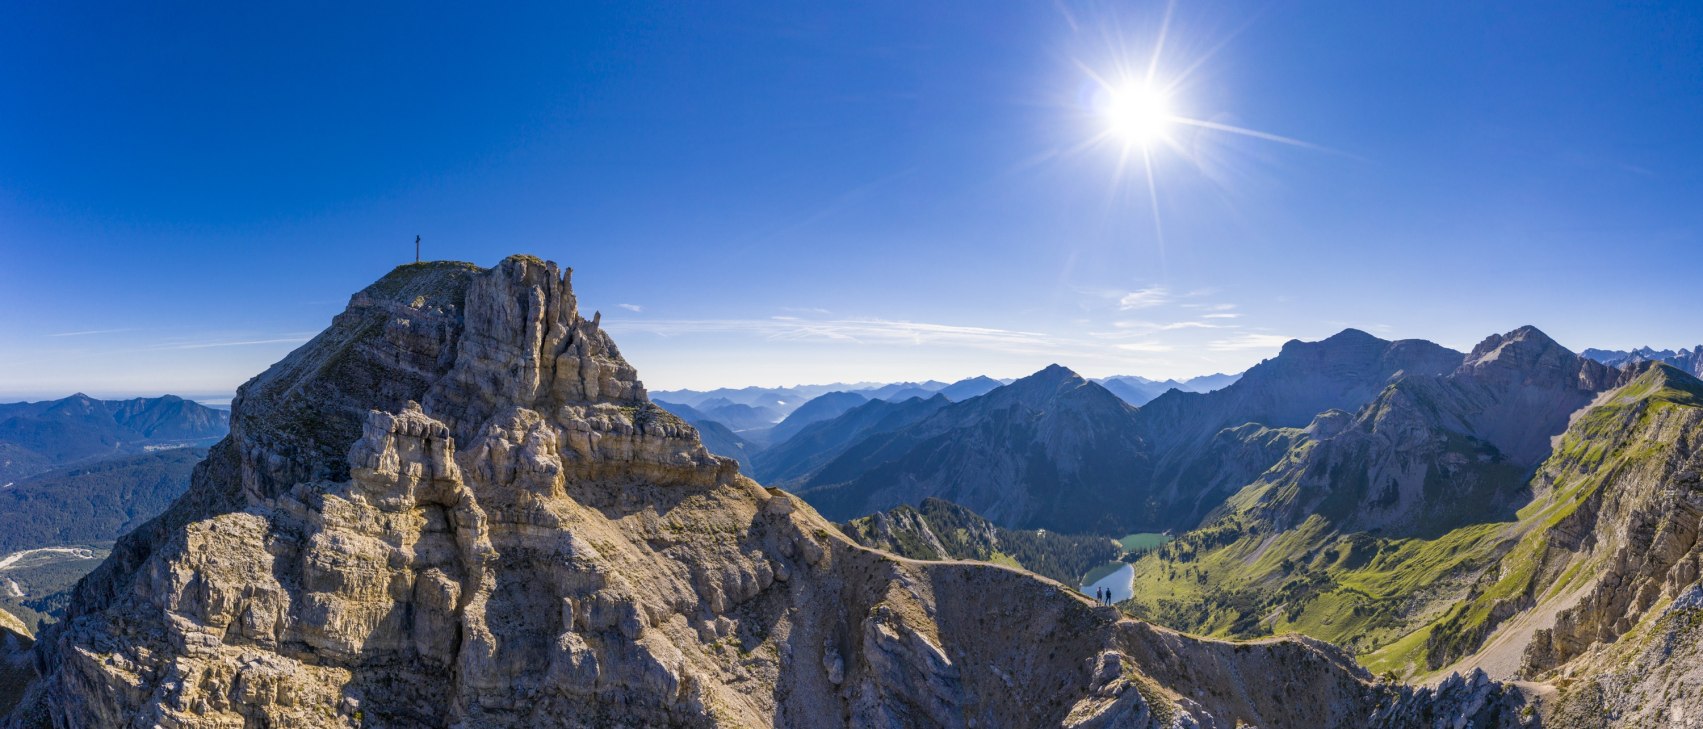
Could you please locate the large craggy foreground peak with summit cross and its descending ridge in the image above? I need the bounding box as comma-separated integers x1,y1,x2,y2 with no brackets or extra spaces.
10,255,1529,729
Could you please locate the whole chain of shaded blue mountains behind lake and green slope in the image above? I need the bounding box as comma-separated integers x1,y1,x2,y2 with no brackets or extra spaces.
670,327,1696,545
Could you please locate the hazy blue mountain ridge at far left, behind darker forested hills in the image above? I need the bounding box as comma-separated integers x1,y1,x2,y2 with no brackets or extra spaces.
0,393,230,484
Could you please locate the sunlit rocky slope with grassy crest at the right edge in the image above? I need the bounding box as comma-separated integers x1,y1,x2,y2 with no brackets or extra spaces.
1403,363,1703,727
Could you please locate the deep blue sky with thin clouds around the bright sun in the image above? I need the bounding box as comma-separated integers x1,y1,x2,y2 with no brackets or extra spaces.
0,2,1703,399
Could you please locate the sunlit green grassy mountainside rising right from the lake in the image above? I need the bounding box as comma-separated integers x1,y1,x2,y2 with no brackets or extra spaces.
1126,368,1703,676
